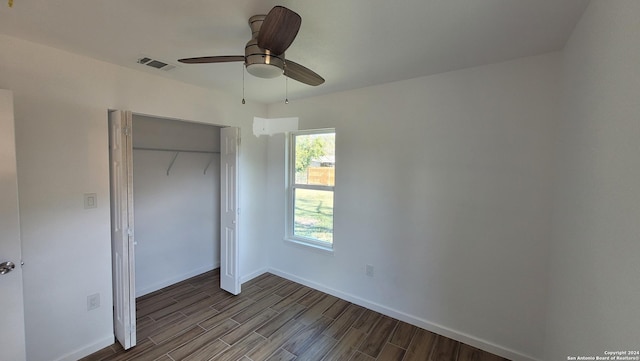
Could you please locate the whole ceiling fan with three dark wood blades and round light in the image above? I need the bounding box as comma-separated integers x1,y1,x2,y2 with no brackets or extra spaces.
178,6,324,86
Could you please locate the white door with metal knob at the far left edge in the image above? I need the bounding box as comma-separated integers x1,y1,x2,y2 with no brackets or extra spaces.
0,89,26,361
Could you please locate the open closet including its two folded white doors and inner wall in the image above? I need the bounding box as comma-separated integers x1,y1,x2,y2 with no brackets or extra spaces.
109,110,240,349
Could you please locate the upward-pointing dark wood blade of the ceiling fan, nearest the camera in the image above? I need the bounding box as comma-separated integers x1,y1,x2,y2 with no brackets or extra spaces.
258,6,302,55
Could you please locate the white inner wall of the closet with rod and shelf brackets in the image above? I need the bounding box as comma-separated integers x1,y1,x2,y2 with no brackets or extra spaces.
133,115,220,297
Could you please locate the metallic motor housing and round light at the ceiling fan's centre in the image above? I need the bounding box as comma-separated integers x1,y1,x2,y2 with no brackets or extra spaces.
244,15,284,79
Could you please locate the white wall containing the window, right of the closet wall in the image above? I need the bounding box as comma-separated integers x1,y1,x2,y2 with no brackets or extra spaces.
268,53,560,360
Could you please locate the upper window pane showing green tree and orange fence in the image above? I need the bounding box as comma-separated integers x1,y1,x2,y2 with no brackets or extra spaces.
295,133,336,186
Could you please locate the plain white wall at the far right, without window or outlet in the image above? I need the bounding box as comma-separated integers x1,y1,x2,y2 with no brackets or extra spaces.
546,0,640,360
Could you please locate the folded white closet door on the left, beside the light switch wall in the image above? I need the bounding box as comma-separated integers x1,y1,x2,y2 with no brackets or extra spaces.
109,111,136,350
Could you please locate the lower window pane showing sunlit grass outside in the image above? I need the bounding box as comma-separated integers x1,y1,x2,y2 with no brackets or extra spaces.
293,188,333,243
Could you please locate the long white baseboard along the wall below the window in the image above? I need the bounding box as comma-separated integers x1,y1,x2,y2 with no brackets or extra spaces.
266,268,539,361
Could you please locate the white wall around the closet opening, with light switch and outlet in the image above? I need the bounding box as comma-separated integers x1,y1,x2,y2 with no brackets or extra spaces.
0,36,266,361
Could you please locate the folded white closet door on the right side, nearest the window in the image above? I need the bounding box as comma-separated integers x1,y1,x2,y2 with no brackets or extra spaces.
220,127,240,295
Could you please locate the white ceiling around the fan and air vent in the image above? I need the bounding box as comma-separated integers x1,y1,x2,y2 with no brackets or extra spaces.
0,0,588,103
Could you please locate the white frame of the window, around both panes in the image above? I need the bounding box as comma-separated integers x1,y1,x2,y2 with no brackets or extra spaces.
285,128,336,253
